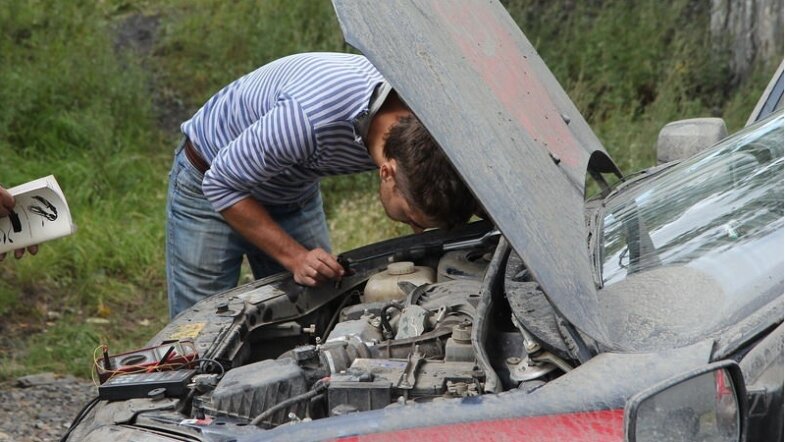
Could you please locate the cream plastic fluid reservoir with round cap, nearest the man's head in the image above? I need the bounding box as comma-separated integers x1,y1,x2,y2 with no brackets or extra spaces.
363,261,436,302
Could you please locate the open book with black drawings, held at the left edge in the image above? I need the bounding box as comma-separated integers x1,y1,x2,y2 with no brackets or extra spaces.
0,175,76,253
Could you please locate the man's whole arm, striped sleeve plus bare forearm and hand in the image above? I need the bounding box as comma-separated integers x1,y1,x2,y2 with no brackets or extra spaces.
202,96,343,286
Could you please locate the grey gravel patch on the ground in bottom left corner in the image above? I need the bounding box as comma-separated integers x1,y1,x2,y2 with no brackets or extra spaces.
0,373,97,442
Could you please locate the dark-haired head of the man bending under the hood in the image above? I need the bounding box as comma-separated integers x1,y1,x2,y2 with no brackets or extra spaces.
379,114,476,231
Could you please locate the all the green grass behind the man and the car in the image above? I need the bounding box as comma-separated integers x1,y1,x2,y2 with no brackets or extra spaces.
0,0,776,379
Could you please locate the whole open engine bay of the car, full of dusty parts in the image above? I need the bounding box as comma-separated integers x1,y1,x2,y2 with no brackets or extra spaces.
86,222,580,439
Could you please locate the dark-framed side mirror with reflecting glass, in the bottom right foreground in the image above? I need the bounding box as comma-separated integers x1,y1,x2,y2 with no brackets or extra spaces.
624,361,747,442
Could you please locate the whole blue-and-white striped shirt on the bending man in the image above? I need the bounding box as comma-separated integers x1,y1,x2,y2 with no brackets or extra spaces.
180,53,385,211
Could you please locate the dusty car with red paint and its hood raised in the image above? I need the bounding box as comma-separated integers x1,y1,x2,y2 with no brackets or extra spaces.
64,0,784,441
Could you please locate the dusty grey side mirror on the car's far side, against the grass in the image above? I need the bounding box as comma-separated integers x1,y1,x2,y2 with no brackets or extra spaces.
657,118,728,164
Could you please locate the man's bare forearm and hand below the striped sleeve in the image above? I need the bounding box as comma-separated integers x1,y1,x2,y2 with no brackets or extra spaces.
221,198,344,286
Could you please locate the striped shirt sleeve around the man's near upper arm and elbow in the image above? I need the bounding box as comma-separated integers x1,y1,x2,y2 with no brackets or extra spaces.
202,95,316,212
